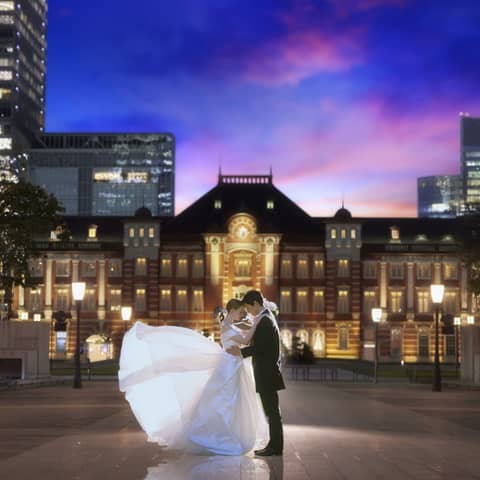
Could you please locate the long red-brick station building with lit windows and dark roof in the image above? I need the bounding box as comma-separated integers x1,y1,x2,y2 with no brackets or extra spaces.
6,175,476,362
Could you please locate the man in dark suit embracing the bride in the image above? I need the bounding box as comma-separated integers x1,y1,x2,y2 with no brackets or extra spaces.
227,290,285,457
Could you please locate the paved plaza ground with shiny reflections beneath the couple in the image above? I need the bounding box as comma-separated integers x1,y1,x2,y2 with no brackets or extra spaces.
0,380,480,480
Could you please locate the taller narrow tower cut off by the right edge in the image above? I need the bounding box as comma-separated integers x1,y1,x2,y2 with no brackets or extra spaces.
460,114,480,213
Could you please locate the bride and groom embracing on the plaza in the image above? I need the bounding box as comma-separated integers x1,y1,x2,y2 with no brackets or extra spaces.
119,290,285,456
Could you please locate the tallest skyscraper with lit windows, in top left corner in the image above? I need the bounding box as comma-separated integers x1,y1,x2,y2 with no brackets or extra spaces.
0,0,47,155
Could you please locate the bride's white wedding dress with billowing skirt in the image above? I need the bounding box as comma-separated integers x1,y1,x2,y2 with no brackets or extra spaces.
118,322,268,455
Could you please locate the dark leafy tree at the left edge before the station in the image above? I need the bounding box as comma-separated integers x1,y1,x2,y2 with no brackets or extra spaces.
0,180,63,318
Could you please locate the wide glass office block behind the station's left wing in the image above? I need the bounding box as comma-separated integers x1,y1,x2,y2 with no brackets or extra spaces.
28,133,175,216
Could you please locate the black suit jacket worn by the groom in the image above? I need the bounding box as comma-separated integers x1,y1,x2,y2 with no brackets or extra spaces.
241,313,285,393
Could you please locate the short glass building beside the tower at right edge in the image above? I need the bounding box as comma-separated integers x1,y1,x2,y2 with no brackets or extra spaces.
417,175,463,218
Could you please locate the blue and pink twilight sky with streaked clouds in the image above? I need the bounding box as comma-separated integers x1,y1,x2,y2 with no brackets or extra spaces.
46,0,480,217
